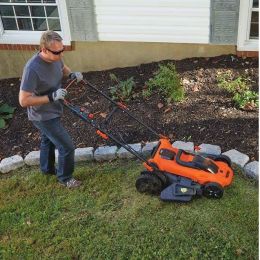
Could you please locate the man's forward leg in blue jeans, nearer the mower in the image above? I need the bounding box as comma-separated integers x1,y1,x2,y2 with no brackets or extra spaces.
33,118,75,183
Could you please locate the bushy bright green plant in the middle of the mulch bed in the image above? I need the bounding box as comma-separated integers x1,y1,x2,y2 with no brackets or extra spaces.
143,63,184,102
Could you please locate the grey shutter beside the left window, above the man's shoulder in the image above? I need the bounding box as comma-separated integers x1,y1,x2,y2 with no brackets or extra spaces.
66,0,97,41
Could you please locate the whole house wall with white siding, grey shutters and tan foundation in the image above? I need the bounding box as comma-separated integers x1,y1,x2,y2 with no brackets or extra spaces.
0,0,239,78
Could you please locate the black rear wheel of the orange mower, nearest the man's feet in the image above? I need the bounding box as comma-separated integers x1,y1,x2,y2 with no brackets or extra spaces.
135,172,162,195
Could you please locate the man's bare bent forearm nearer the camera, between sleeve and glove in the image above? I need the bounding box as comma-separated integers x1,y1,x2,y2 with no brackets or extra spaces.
19,90,50,107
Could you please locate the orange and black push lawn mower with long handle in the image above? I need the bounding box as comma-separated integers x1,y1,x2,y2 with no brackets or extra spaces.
64,80,234,202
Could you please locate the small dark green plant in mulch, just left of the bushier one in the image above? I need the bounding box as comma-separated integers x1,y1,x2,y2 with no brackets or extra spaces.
109,74,135,101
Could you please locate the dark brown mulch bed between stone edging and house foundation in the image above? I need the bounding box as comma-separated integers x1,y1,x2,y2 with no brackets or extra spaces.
0,55,258,160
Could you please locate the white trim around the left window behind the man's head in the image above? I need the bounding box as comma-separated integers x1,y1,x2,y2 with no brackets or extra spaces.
0,0,71,45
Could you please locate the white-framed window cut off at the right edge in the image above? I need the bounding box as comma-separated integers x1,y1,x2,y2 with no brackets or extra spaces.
237,0,259,51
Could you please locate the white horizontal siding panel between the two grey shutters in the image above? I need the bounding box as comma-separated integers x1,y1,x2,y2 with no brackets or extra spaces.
94,0,210,43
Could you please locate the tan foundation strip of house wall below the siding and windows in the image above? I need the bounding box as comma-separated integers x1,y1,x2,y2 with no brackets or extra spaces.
0,42,236,78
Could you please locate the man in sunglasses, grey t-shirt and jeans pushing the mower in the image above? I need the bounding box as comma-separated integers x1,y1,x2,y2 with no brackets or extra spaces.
19,31,83,188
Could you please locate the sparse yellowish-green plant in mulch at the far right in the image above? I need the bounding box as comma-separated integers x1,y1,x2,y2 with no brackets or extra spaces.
217,73,259,110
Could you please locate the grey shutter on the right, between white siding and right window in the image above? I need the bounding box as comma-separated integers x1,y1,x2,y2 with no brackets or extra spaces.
210,0,240,45
